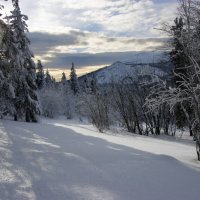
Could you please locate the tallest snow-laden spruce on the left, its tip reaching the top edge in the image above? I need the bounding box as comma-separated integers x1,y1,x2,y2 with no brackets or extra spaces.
7,0,39,122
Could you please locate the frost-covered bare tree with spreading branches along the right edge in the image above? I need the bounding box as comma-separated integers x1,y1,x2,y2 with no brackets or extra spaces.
146,0,200,159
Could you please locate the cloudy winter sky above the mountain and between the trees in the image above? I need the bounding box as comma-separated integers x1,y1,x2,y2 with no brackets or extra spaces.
1,0,177,77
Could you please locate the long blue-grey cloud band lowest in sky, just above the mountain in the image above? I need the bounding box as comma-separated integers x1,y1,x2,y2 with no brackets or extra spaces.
45,51,163,69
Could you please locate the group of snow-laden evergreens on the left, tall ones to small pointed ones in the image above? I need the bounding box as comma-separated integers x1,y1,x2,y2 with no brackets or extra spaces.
0,0,78,122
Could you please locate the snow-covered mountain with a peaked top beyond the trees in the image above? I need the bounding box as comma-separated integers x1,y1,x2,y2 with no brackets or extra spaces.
79,61,172,84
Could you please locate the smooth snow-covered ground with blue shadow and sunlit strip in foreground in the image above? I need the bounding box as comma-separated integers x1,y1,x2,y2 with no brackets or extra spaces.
0,119,200,200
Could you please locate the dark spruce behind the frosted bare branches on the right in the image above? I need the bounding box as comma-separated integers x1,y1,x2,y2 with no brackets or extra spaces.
170,17,193,136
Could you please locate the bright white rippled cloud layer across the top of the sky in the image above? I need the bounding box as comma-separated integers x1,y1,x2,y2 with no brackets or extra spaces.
2,0,177,38
